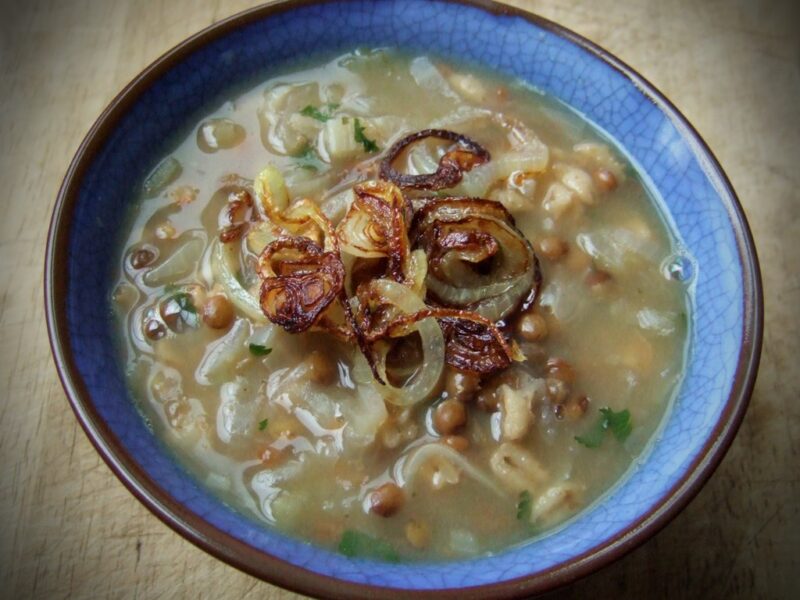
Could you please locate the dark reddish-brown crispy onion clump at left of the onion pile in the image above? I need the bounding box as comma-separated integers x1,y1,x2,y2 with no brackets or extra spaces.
258,236,344,333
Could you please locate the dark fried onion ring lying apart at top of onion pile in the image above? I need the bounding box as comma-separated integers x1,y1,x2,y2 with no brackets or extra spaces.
381,129,491,190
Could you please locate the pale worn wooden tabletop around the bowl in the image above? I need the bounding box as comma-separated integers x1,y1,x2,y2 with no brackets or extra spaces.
0,0,800,599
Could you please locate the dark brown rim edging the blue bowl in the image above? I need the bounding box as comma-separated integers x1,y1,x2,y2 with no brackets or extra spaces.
44,0,764,599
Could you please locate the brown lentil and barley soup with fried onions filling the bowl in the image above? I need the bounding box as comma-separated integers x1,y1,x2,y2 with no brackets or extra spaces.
113,49,688,560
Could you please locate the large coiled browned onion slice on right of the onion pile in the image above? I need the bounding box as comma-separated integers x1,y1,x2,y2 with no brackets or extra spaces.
411,198,540,322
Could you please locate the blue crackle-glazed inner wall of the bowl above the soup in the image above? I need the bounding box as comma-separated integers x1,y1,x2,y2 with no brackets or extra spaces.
66,0,744,589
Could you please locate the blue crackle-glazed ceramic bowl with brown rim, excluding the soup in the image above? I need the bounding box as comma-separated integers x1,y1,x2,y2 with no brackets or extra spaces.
45,0,762,598
